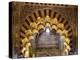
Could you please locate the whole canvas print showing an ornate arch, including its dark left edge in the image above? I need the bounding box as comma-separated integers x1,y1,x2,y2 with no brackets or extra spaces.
9,2,78,58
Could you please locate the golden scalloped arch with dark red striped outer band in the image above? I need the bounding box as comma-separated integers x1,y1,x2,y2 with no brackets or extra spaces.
20,9,72,57
